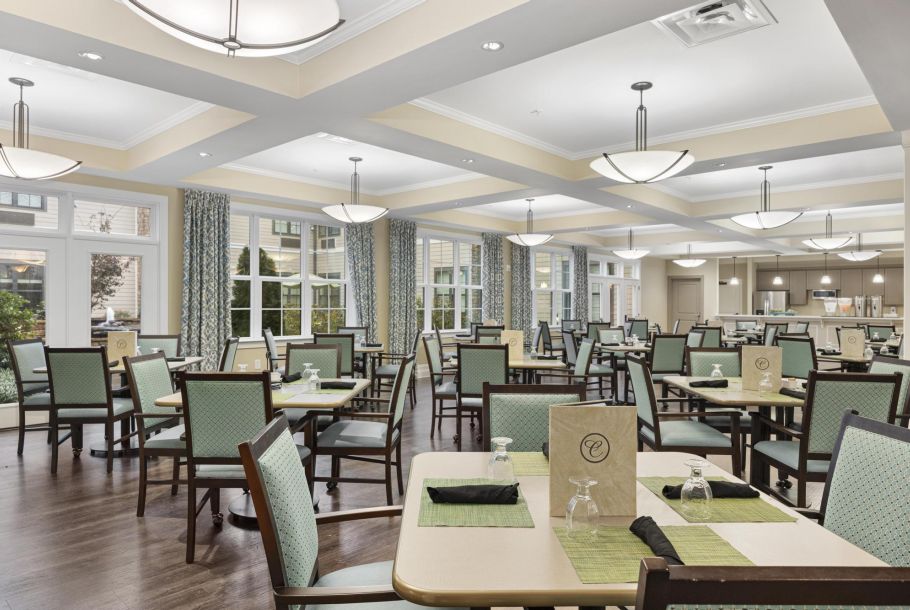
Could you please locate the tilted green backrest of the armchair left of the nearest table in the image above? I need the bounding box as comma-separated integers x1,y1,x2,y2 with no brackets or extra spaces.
239,414,319,589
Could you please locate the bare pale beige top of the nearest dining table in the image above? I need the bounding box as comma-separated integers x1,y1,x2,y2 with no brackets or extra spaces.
392,452,885,607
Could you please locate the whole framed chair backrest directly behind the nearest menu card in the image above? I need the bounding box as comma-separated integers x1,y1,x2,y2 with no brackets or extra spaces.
482,383,585,451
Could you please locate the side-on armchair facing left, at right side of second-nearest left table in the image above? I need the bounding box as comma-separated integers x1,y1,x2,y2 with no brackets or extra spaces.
313,354,415,505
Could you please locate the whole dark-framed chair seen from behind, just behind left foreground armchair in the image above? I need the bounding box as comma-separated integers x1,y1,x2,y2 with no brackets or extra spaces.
180,371,313,563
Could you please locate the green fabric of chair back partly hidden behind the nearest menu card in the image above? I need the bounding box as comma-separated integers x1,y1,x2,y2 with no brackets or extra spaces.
489,392,579,451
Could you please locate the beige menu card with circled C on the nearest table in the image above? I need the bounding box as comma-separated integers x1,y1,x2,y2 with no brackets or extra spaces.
550,401,638,517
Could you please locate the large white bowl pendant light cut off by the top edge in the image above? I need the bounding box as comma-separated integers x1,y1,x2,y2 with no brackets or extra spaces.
124,0,344,57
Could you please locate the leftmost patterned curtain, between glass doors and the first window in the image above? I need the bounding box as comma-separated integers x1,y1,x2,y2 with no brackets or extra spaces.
180,189,231,371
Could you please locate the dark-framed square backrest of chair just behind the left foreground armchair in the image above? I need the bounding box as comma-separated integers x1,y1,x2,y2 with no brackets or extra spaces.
180,371,272,460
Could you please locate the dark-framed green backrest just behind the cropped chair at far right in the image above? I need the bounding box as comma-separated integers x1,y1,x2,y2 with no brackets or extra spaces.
800,371,902,459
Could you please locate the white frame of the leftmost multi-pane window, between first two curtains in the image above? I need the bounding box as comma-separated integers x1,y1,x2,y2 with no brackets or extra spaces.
231,202,357,341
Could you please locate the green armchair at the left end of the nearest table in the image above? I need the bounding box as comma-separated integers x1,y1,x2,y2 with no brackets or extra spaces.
240,417,466,610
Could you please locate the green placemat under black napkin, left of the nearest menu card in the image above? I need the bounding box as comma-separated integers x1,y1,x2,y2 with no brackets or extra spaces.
417,479,534,527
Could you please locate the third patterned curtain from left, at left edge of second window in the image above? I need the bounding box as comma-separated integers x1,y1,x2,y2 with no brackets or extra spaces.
389,218,418,354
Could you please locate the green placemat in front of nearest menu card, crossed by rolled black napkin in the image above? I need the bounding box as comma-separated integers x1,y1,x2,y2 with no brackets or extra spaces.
553,525,752,585
